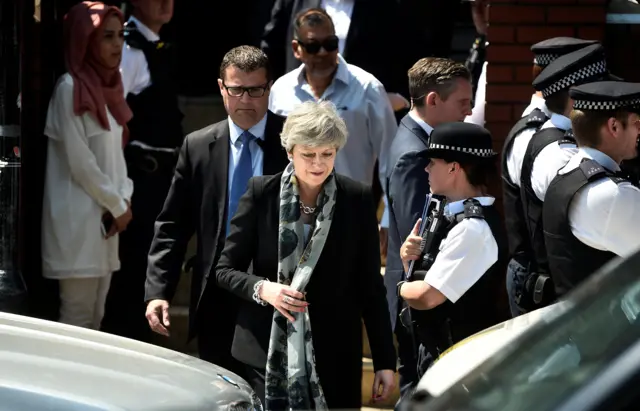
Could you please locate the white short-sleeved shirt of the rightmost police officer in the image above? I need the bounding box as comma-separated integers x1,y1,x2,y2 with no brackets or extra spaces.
559,147,640,257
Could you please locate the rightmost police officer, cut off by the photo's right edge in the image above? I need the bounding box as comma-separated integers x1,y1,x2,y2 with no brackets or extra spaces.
542,81,640,297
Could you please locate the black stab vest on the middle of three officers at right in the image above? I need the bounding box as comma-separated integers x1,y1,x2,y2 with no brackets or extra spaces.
520,127,576,274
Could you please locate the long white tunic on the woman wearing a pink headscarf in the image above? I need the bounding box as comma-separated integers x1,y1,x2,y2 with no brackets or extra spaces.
42,74,133,279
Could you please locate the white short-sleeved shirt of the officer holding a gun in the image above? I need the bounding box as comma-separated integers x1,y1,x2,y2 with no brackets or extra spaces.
424,197,498,303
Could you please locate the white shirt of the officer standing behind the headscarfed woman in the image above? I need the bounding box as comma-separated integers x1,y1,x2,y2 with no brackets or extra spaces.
120,16,160,96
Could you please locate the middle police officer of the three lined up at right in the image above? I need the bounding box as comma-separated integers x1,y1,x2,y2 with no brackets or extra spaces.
515,44,608,311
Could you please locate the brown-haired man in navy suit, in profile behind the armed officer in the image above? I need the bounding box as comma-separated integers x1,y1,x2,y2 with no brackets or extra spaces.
384,57,471,402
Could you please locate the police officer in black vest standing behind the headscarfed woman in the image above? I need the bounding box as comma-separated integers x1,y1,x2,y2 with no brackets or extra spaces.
102,0,184,341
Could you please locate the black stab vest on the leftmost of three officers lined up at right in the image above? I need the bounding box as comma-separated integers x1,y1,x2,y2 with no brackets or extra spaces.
501,109,548,267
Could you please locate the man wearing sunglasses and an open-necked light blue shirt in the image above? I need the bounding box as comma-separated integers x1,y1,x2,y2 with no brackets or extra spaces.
269,8,398,256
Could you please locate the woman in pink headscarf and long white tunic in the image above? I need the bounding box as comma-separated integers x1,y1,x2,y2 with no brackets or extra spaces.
42,2,133,329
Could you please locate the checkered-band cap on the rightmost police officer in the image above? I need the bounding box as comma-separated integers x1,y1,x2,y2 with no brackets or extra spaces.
569,81,640,113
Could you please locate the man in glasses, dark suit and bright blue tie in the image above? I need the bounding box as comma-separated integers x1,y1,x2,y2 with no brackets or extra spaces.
145,46,288,374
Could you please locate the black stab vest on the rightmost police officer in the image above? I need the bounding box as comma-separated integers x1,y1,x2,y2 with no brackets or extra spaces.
542,159,628,297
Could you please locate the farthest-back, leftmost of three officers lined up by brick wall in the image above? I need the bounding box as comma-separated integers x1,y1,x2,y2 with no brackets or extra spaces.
501,37,596,317
